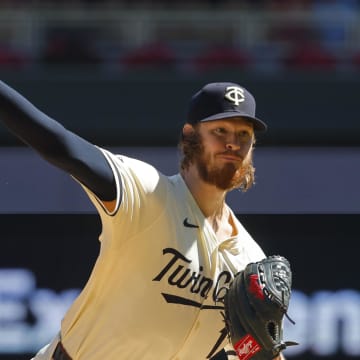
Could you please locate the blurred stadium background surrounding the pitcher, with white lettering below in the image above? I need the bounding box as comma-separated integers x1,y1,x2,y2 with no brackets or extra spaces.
0,0,360,360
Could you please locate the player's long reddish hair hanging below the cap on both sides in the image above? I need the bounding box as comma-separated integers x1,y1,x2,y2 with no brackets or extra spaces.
178,124,255,192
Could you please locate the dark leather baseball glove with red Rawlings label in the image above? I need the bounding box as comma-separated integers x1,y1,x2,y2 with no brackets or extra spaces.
224,255,297,360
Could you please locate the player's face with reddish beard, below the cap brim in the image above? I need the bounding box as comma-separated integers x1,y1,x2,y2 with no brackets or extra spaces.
194,118,254,190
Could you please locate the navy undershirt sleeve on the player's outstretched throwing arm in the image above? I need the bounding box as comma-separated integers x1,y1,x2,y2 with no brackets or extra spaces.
0,81,116,201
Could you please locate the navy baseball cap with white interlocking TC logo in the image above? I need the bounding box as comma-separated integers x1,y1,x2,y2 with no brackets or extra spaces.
187,82,267,131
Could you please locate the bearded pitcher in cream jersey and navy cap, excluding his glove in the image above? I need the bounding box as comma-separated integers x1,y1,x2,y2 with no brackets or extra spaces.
0,82,286,360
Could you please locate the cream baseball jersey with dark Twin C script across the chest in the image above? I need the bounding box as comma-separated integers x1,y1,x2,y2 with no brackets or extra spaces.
55,150,265,360
